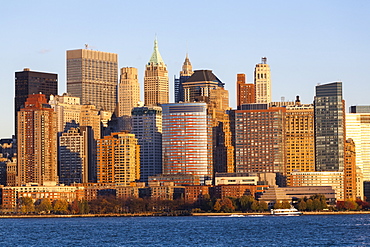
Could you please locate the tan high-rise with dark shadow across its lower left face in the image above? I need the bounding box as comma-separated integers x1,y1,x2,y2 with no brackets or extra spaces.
58,126,95,185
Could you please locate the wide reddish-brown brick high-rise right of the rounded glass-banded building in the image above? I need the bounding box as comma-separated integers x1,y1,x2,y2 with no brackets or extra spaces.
232,107,286,185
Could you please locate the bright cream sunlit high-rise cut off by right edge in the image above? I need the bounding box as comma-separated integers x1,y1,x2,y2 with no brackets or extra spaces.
346,106,370,181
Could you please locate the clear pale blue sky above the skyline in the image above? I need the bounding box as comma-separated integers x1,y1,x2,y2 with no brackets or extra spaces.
0,0,370,138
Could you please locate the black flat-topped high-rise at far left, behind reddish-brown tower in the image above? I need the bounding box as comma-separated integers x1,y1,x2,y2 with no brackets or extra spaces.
14,68,58,136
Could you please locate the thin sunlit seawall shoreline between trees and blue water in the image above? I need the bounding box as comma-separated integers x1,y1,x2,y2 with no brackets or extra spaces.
0,211,370,219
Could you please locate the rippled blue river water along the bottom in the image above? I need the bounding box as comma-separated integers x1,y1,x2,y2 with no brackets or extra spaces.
0,214,370,246
